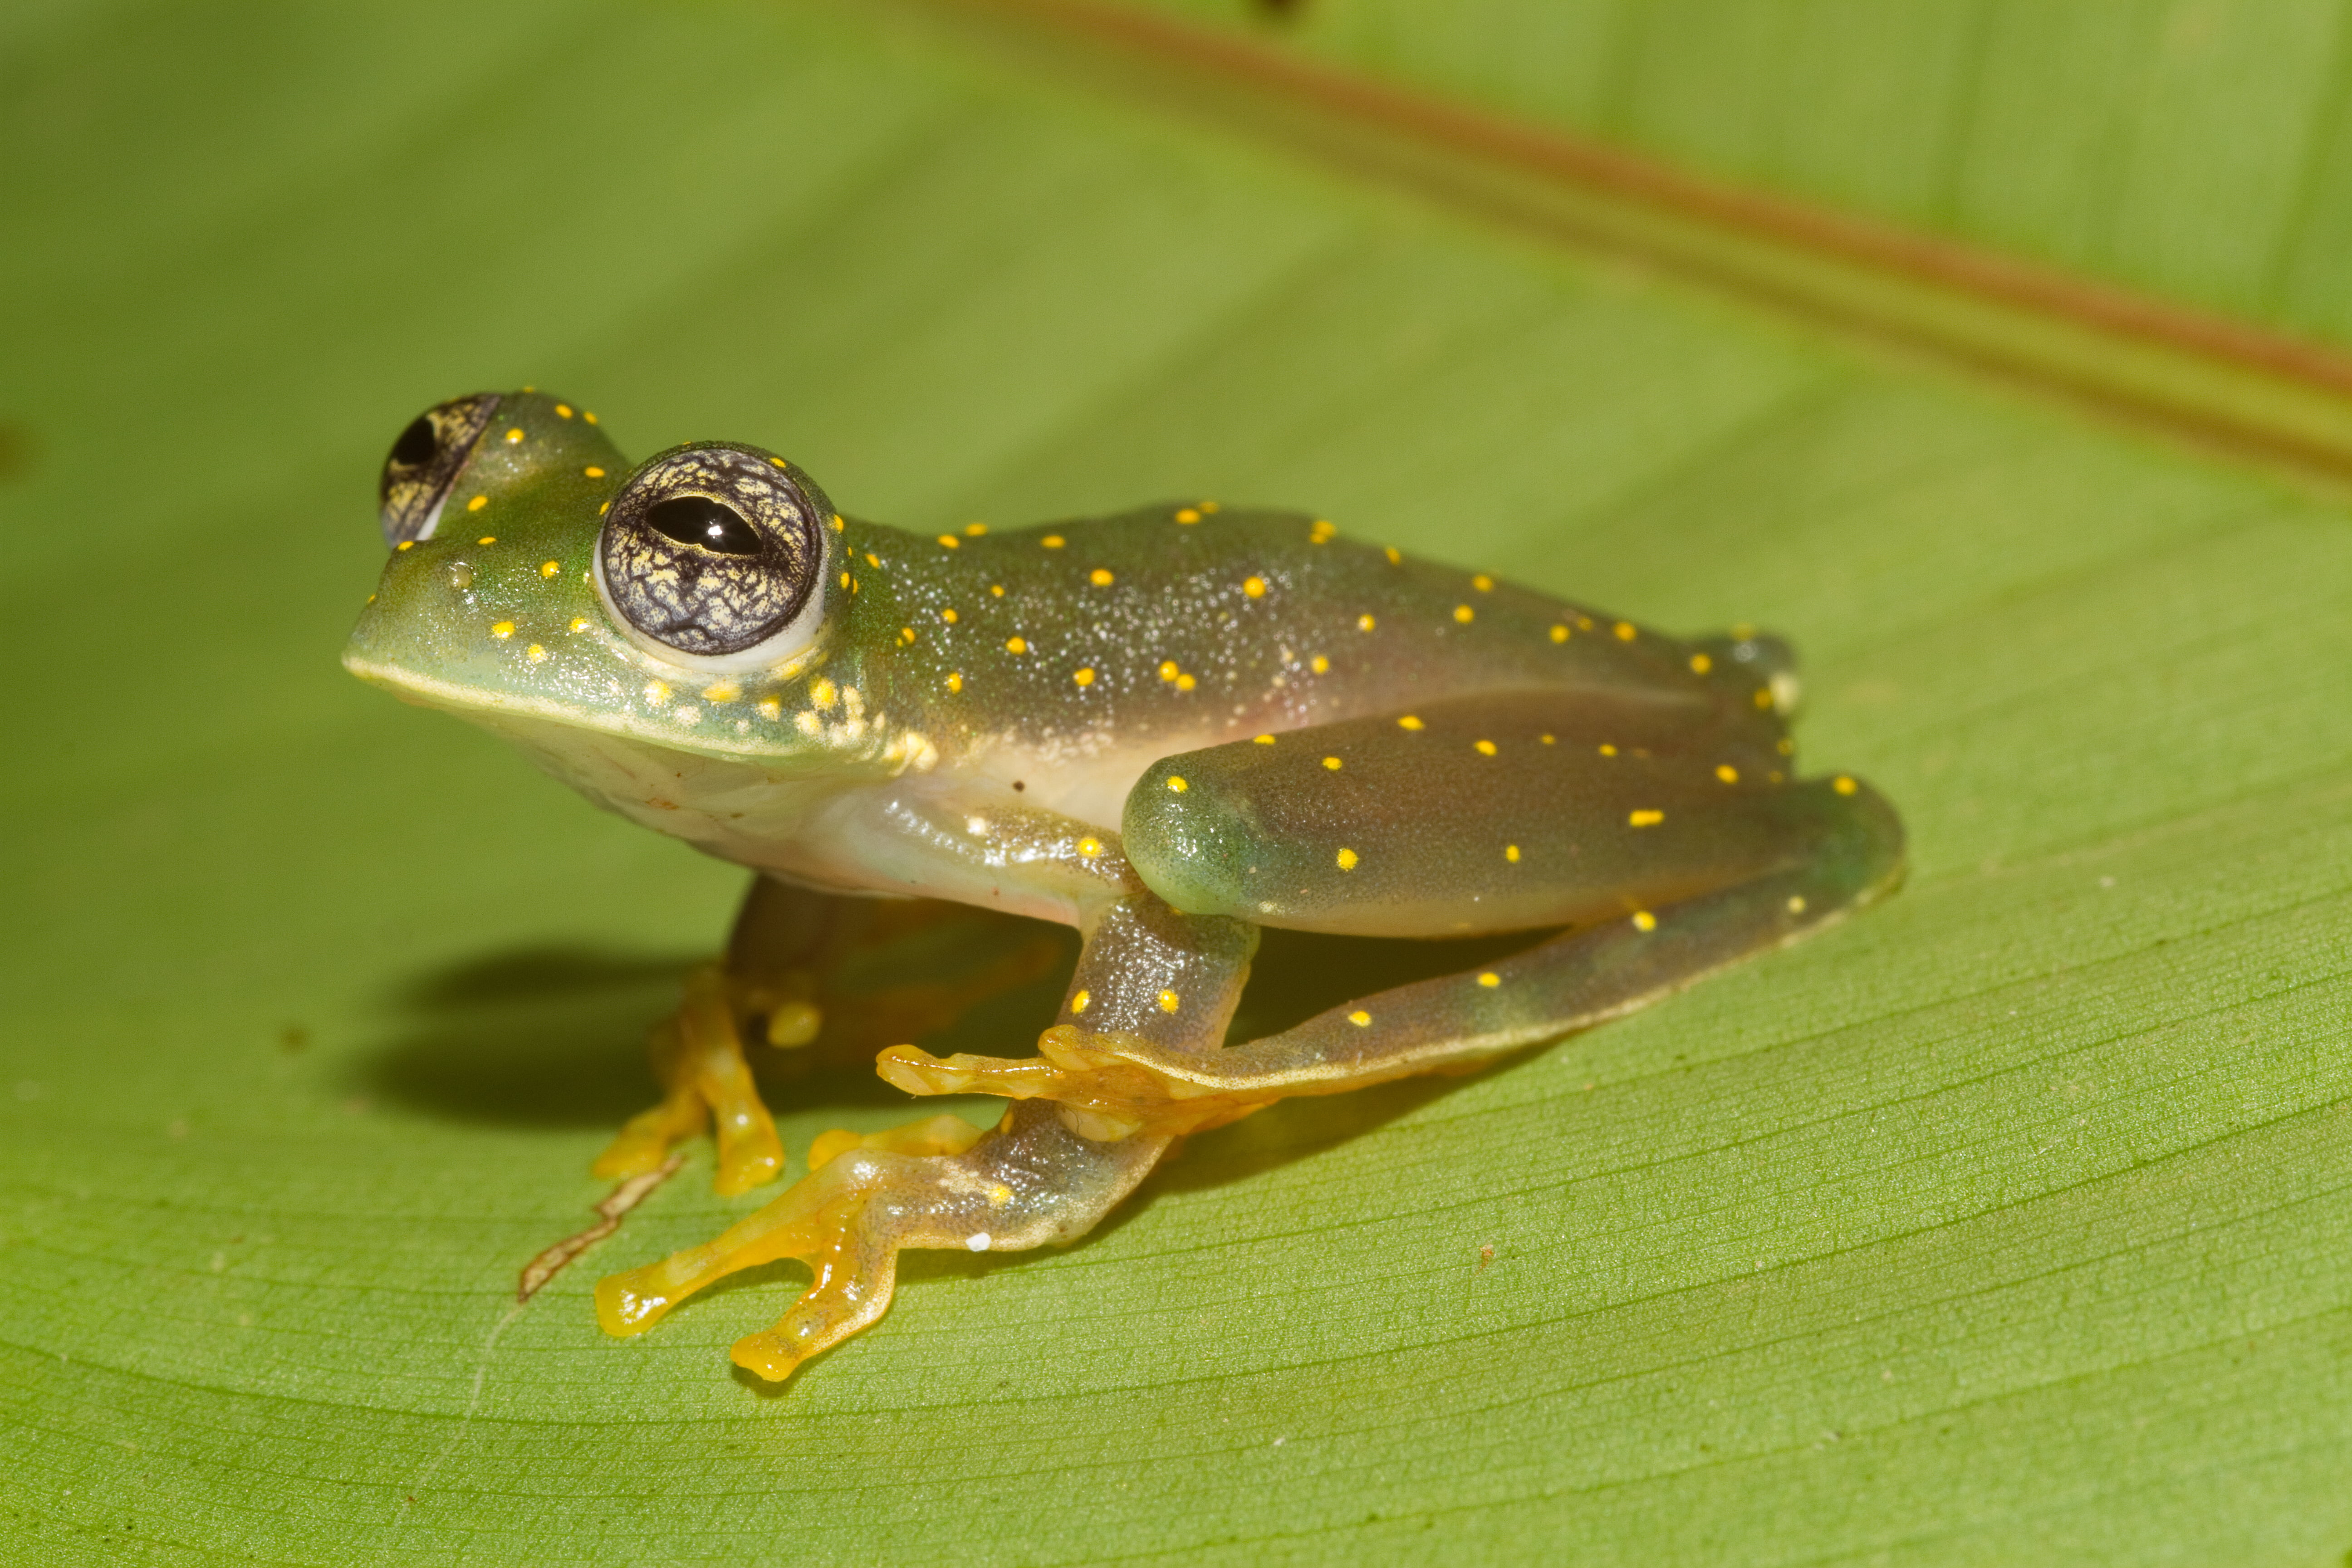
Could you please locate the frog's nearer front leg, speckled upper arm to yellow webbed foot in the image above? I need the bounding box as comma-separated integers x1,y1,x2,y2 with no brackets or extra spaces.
598,841,1256,1380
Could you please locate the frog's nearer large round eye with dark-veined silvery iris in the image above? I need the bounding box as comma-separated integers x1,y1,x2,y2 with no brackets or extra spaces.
598,446,828,668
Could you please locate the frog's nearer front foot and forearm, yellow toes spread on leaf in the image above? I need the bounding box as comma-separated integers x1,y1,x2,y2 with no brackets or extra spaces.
598,1107,1169,1382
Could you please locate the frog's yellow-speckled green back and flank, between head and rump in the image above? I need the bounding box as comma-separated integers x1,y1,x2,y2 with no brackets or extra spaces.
852,503,1785,771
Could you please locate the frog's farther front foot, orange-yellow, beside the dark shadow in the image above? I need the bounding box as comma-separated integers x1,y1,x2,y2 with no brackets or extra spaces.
593,964,783,1196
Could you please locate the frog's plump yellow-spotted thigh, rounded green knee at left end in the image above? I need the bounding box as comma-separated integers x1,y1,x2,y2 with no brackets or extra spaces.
1122,689,1808,936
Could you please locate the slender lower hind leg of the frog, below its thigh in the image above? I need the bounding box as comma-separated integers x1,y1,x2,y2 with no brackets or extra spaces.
1115,776,1903,1102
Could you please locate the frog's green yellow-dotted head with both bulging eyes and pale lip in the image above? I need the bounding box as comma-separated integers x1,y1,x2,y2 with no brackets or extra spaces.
343,388,887,769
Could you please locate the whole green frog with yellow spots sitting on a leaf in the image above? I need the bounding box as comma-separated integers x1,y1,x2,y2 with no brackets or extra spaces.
343,388,1905,1382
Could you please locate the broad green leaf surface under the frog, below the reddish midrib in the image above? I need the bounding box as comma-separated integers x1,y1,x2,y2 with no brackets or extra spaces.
0,2,2352,1563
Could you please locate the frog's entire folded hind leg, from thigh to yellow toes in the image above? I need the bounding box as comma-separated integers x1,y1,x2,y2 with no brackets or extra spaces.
880,691,1903,1114
